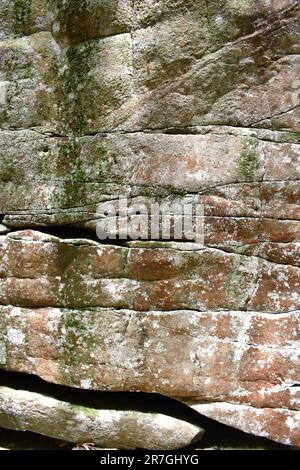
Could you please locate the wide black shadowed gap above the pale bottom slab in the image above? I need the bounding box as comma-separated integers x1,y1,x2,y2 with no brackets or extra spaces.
0,370,290,449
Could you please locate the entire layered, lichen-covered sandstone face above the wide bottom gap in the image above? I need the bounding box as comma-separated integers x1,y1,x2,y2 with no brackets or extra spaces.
0,0,300,448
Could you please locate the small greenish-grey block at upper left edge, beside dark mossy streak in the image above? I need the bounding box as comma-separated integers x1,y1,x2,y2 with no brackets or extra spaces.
0,32,60,131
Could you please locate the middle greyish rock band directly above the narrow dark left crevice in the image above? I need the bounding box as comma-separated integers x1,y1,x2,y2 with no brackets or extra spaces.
0,130,300,264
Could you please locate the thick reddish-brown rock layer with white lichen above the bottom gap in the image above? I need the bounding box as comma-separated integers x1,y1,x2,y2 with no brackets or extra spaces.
0,230,300,445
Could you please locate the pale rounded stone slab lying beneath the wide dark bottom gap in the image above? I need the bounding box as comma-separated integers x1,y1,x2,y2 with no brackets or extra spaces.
0,387,201,449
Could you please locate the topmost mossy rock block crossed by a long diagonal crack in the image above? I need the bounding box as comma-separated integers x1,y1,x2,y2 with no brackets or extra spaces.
3,0,299,133
